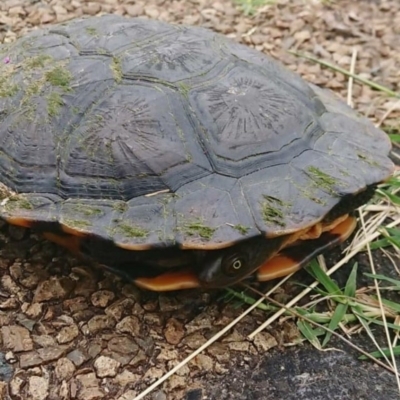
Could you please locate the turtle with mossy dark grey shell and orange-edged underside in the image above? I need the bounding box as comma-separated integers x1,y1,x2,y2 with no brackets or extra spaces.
0,15,394,291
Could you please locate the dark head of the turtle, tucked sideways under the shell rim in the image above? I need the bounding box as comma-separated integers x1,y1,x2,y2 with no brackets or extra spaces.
198,237,282,288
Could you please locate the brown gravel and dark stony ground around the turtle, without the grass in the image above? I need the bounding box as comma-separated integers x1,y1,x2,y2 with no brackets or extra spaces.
0,0,400,400
